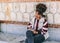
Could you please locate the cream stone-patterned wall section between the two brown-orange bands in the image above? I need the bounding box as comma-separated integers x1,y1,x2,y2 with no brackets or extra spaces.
0,2,60,24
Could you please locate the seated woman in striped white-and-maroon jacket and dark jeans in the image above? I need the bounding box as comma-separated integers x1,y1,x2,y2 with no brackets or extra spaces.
26,3,49,43
